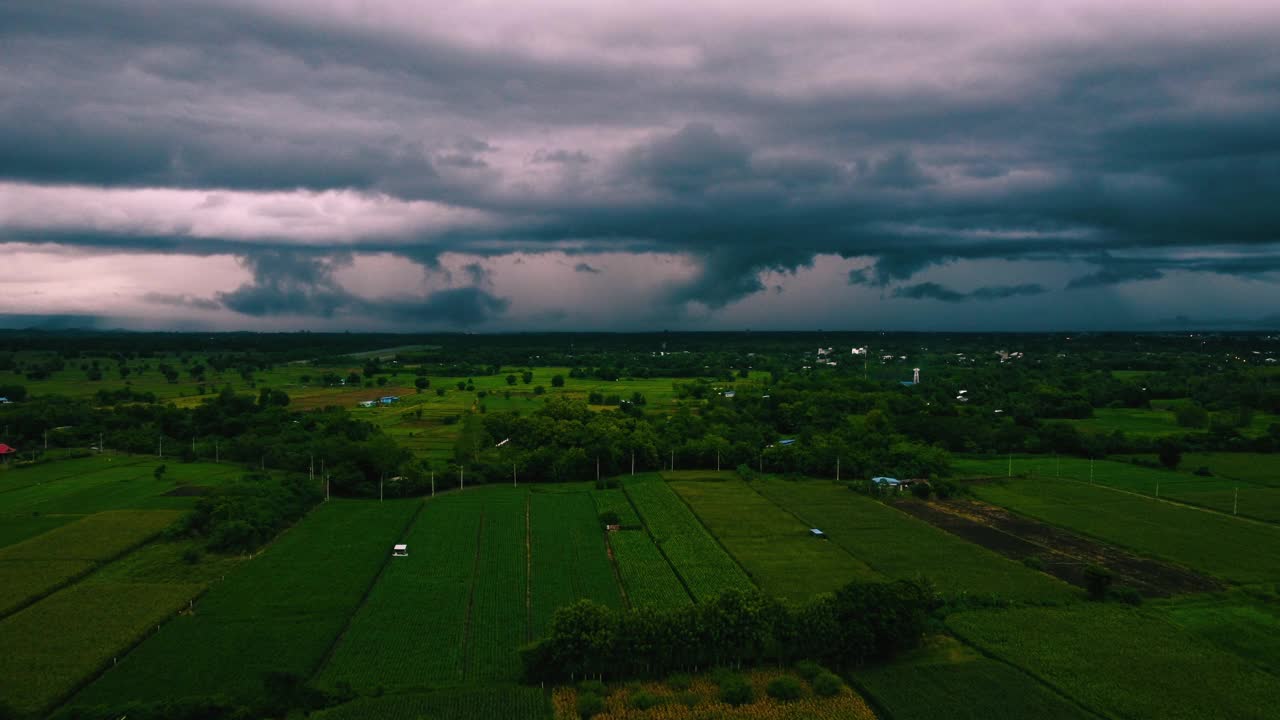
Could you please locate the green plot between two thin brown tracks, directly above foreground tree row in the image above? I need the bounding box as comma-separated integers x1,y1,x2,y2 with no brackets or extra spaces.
530,492,622,638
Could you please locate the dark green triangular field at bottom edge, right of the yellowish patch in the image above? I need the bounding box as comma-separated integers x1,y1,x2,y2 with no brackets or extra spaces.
852,635,1097,720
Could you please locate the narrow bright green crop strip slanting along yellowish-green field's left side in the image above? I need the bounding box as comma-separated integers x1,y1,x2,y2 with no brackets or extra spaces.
622,475,754,601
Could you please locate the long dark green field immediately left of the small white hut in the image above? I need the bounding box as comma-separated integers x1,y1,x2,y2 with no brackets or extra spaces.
76,501,419,705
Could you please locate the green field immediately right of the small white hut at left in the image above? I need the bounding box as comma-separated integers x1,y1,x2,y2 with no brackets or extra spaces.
319,493,483,691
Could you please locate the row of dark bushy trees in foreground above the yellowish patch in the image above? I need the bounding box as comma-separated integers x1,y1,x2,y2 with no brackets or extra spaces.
520,580,936,683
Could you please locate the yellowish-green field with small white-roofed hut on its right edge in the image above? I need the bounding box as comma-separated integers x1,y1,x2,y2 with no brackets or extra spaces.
669,480,879,600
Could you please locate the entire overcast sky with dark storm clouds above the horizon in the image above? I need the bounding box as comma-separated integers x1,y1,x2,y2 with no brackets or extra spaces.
0,0,1280,331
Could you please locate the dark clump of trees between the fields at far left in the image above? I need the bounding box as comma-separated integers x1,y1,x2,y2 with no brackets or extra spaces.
168,473,323,552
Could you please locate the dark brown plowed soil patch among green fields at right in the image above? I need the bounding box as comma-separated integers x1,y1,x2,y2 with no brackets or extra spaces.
896,500,1222,597
